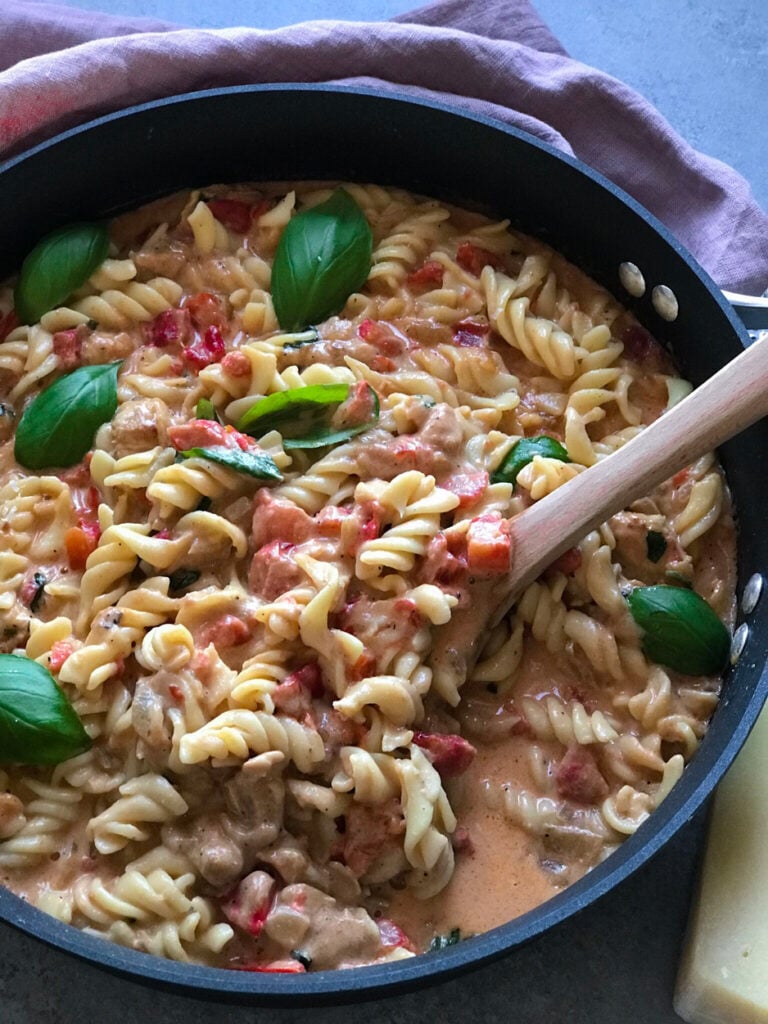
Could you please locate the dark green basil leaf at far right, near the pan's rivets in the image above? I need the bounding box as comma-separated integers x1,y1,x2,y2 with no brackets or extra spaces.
627,584,730,676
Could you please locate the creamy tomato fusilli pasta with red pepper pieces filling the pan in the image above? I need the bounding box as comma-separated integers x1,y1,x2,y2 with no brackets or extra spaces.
0,183,735,973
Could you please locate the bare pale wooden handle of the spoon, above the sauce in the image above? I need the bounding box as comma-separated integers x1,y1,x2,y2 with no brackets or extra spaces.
511,336,768,594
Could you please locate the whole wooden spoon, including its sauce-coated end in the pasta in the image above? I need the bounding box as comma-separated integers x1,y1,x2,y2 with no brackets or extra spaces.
430,335,768,703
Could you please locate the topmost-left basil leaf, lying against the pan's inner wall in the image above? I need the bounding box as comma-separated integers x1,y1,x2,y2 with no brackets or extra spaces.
13,224,110,324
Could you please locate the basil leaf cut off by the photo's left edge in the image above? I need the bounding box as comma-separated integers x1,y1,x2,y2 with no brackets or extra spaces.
0,654,91,765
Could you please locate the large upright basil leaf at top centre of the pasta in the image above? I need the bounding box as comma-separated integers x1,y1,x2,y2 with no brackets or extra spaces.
271,188,373,331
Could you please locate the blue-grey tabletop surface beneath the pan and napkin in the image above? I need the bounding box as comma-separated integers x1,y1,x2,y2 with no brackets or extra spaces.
0,0,768,1024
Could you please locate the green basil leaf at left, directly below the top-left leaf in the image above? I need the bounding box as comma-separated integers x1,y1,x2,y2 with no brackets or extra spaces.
14,362,121,469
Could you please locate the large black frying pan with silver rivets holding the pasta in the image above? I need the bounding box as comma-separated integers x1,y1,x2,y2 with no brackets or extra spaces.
0,85,768,1007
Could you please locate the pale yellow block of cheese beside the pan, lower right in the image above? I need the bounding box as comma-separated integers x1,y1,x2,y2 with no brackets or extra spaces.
675,708,768,1024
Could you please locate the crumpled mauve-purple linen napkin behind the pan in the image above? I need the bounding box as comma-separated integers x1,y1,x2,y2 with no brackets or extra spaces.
0,0,768,294
